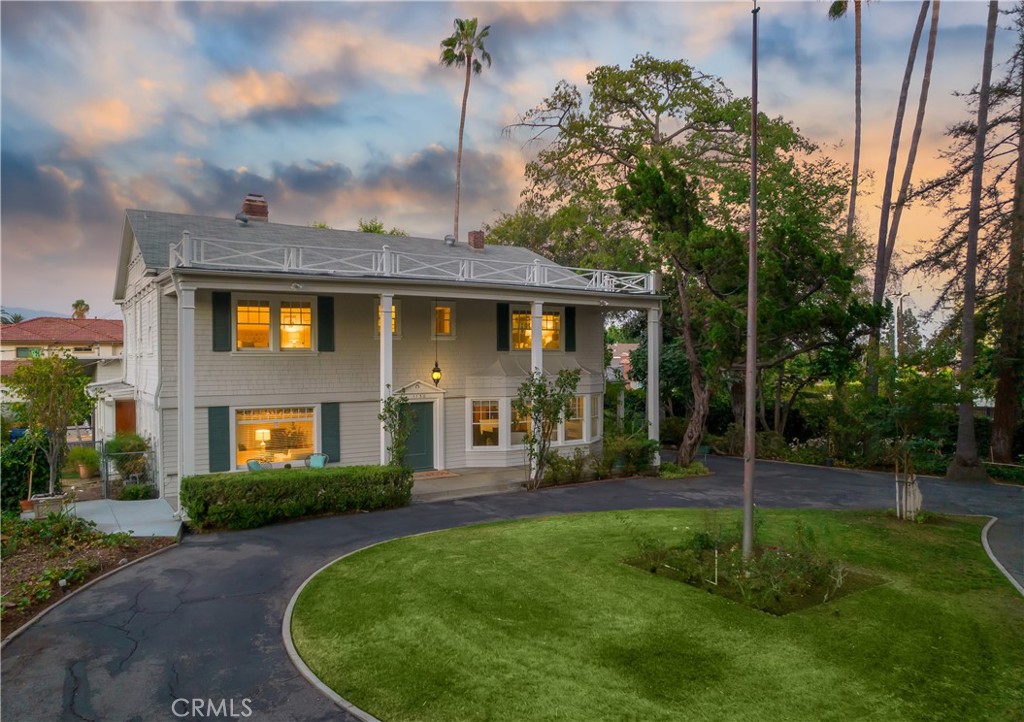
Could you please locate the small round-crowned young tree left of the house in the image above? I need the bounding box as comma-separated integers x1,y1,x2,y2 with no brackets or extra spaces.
6,354,94,495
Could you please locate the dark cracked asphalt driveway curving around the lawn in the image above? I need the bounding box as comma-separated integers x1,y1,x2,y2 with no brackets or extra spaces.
2,459,1024,722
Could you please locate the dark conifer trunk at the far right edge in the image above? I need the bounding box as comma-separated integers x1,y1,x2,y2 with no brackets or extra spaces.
992,32,1024,464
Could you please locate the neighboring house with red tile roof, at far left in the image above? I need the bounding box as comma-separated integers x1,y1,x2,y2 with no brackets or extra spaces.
0,316,129,438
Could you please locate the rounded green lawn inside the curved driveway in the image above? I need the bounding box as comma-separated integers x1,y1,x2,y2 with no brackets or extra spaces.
292,510,1024,722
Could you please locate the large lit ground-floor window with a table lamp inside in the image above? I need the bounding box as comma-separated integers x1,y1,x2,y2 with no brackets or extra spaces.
234,407,316,468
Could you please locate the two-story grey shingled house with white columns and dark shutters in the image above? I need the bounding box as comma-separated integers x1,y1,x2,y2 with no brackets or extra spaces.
114,197,660,499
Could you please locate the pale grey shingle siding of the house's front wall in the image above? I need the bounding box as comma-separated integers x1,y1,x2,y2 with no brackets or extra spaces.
159,291,604,481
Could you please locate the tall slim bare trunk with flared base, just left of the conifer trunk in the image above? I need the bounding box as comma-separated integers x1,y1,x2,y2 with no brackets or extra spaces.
946,0,999,479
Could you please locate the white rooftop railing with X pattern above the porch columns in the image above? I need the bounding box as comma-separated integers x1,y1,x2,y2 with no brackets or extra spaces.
164,230,655,294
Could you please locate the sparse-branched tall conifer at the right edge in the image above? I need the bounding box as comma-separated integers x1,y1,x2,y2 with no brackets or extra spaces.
910,3,1024,463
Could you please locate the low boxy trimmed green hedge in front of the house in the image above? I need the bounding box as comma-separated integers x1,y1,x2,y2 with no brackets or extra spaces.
181,466,413,529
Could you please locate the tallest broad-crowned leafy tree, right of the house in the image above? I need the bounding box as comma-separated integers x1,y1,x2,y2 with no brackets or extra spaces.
499,55,867,462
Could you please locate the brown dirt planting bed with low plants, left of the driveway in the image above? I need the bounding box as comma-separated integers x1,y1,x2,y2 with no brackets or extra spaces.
0,533,177,637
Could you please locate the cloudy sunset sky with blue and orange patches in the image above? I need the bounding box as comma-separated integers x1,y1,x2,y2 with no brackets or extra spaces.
0,0,1012,317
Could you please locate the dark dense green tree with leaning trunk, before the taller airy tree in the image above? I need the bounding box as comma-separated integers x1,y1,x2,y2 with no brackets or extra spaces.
616,158,878,463
